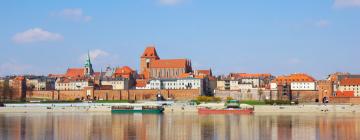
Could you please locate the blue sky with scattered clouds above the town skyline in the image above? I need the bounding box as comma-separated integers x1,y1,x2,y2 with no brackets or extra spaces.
0,0,360,79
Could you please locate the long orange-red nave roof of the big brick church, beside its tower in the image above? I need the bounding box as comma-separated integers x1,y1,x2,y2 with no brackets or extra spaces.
150,59,188,68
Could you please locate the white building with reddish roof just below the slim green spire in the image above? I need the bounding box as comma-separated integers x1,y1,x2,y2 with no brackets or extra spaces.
55,78,93,90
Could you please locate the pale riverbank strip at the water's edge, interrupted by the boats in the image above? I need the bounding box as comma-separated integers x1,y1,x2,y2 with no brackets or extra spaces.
0,103,360,113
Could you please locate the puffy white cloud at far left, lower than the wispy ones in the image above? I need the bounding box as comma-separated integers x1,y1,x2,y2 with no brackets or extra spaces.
12,28,64,44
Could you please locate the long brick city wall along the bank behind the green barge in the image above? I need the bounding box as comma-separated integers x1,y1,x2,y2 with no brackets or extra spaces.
26,89,200,100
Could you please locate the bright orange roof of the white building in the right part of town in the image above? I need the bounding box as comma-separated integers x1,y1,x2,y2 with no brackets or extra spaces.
273,73,315,83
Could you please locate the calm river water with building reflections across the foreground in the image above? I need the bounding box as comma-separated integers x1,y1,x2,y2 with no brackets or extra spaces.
0,113,360,140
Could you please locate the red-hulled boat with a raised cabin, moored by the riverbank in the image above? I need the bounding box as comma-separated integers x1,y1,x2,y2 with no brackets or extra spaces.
198,100,254,114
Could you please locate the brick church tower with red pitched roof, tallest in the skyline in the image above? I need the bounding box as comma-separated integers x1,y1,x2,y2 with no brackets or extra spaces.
140,45,160,77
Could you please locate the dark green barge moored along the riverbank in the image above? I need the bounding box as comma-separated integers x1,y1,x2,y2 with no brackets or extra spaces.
111,105,164,114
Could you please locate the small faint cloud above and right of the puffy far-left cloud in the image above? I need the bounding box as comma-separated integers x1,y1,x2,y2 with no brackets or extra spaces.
51,8,92,22
